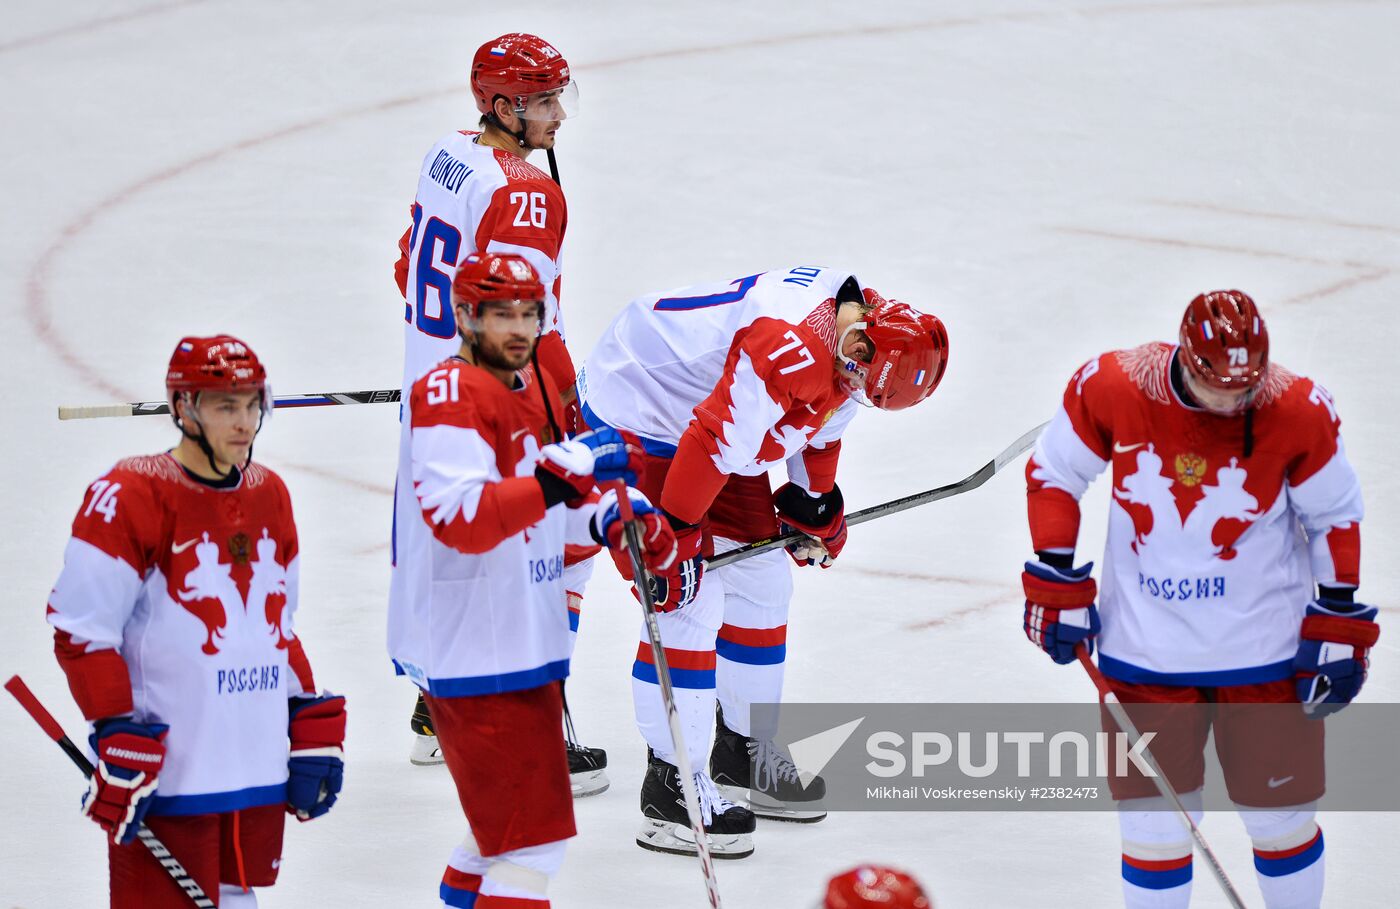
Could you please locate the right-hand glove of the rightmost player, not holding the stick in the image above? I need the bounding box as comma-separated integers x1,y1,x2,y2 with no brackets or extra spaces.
1294,597,1380,720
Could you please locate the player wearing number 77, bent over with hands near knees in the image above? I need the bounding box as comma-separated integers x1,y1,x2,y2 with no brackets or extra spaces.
578,266,948,859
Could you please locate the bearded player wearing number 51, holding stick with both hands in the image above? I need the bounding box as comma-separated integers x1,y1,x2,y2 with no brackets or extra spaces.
389,254,675,909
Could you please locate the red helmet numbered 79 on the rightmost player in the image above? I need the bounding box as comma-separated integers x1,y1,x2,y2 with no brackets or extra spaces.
1180,290,1268,389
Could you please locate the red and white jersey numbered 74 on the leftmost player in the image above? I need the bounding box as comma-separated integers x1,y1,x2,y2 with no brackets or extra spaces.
49,454,315,814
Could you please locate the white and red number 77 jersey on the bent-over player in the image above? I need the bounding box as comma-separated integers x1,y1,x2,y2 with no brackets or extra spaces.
578,266,858,521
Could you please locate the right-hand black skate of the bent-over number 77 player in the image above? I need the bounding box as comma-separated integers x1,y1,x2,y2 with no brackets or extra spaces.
710,712,826,824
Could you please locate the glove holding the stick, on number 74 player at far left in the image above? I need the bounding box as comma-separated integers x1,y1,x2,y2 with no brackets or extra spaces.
83,719,169,846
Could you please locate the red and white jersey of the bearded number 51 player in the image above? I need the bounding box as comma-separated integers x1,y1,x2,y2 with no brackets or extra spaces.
389,359,596,698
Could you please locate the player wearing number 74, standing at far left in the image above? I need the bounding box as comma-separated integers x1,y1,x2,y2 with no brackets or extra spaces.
48,335,346,909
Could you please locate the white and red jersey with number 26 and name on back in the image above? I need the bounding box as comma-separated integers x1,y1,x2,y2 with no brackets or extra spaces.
396,130,573,401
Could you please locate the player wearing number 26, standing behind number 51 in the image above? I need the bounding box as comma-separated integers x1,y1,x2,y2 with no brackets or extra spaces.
395,34,608,796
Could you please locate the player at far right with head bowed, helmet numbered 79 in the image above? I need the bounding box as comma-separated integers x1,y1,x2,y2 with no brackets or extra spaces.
1022,290,1379,908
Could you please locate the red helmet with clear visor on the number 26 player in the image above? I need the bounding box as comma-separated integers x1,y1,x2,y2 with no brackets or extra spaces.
472,32,578,120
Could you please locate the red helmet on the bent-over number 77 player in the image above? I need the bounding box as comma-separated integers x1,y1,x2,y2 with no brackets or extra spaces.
837,287,948,410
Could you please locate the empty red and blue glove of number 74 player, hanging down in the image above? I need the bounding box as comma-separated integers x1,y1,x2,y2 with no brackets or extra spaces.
287,695,346,821
